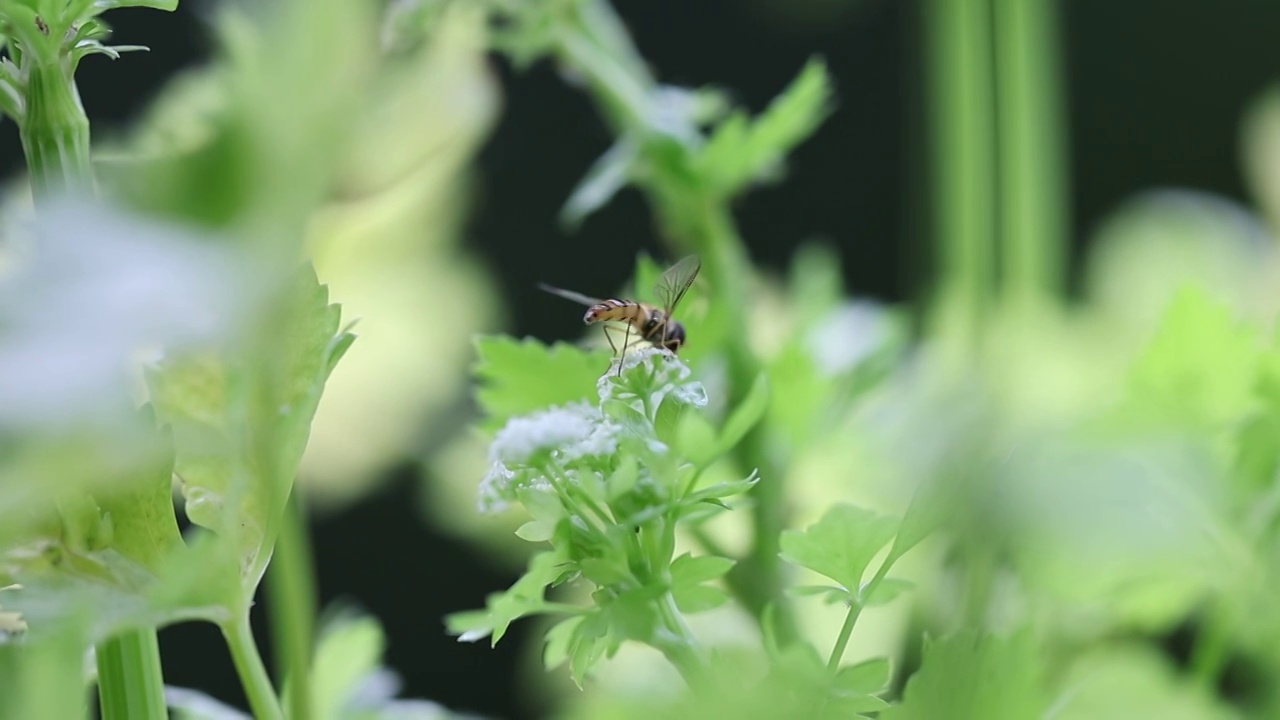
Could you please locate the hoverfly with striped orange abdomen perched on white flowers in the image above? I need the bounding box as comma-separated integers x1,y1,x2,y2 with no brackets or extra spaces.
538,255,703,373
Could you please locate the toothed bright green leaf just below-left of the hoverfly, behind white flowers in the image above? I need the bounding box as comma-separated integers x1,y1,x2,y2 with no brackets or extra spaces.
475,336,608,430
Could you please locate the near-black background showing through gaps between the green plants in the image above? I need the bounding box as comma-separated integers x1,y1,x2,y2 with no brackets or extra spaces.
37,0,1280,717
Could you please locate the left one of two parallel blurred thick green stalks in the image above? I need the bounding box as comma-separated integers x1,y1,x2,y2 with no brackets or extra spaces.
923,0,996,361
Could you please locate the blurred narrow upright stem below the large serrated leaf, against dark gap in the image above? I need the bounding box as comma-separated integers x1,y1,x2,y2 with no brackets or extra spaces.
266,486,316,717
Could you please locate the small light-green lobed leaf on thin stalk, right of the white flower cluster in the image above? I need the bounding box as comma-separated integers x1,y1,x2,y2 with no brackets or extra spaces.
781,503,899,591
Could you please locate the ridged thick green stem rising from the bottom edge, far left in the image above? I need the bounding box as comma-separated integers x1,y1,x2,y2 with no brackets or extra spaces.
96,628,169,720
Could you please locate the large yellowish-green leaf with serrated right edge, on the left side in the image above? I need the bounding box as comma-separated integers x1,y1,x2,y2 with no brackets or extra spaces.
147,265,351,593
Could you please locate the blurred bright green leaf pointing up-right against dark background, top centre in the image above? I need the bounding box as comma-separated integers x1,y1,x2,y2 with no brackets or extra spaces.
698,58,832,196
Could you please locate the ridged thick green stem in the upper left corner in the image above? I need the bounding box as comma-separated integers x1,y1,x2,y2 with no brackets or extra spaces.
18,60,92,202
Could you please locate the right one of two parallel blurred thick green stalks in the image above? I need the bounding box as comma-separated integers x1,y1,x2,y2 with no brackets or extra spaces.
995,0,1068,311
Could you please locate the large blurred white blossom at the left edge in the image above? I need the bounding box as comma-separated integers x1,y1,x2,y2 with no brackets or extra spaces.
0,193,260,429
